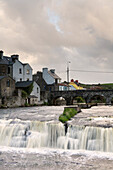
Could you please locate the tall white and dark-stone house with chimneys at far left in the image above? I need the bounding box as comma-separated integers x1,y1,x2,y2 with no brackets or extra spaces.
0,51,32,82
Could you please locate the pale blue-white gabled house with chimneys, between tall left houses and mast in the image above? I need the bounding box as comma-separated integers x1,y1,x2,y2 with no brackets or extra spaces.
42,68,61,85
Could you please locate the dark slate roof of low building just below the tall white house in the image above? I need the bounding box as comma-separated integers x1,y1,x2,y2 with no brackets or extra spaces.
15,81,33,88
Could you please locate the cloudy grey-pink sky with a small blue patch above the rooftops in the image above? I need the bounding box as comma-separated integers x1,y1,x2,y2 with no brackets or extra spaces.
0,0,113,83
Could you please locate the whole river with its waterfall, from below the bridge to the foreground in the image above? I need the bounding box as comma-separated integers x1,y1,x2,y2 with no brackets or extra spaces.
0,106,113,170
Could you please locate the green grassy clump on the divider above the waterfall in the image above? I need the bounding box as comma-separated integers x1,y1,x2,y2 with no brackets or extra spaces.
59,108,77,123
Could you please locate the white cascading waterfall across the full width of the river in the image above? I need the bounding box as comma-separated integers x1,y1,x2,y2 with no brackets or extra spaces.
0,119,113,152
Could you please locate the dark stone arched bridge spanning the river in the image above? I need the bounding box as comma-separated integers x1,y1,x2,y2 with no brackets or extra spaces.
48,90,113,105
